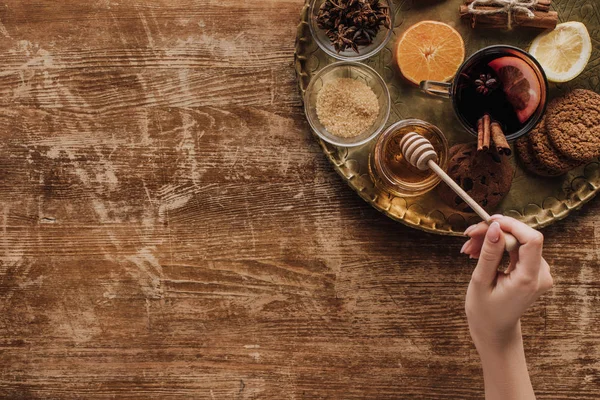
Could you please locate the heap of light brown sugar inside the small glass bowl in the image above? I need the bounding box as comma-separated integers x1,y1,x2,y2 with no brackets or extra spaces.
317,78,379,138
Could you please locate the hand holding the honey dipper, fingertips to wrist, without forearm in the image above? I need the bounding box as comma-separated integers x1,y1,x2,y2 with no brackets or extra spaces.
463,216,552,347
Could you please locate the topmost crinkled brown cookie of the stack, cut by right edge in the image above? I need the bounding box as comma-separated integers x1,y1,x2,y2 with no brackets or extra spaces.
546,89,600,162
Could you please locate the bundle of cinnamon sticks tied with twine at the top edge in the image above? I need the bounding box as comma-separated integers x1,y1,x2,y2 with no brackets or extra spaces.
459,0,558,30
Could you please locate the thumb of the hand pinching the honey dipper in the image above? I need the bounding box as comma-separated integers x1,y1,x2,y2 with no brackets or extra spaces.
473,222,504,286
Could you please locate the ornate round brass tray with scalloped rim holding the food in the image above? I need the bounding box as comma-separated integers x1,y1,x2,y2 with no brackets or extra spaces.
295,0,600,236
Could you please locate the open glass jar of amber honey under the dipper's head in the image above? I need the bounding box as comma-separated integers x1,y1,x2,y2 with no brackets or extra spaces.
369,119,448,197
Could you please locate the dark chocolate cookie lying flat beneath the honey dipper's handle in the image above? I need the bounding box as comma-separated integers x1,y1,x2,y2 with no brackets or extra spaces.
438,144,514,212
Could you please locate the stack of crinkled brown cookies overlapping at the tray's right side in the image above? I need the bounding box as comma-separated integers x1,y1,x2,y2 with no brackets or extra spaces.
515,89,600,177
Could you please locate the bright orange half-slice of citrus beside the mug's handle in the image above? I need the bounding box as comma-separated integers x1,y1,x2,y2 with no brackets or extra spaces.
396,21,465,85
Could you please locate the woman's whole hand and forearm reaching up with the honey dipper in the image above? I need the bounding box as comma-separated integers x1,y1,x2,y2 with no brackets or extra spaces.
461,216,553,400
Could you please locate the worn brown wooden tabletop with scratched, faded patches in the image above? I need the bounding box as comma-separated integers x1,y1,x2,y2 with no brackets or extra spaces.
0,0,600,399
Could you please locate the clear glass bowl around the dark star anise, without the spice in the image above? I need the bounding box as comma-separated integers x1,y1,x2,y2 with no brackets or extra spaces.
308,0,394,61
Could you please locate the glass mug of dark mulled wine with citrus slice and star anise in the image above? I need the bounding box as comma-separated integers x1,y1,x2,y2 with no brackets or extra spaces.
421,46,548,140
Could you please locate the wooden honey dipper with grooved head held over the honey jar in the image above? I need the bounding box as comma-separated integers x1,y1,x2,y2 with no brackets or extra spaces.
400,132,519,251
